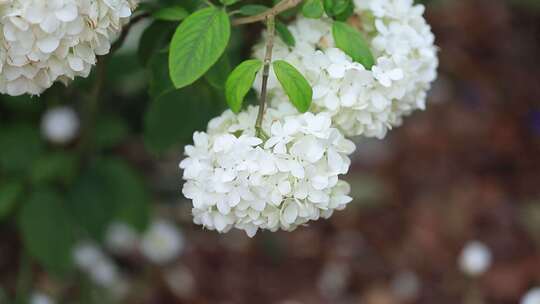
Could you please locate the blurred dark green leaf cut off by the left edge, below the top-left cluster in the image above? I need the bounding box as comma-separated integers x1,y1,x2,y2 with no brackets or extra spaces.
0,124,43,176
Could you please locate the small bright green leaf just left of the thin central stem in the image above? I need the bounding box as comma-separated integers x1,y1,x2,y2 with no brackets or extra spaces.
225,59,262,113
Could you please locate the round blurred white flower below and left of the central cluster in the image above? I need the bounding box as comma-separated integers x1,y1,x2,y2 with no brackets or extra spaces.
140,219,185,264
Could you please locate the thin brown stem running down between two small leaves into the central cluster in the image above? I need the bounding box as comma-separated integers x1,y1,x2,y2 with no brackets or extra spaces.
255,14,276,140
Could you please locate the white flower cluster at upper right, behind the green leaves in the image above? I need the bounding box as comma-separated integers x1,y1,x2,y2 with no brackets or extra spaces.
254,0,438,138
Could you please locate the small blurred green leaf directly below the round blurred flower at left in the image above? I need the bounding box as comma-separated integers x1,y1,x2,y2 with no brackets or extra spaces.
30,151,78,184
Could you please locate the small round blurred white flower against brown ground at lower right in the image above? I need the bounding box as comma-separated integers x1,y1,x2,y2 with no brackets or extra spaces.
459,241,492,277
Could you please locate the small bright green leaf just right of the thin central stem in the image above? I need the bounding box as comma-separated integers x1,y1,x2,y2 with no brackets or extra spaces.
273,60,313,113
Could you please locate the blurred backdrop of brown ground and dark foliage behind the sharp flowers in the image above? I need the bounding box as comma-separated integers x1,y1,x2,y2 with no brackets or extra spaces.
0,0,540,304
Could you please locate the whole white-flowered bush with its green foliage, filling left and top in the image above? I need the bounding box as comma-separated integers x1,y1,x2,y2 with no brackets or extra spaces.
0,0,437,303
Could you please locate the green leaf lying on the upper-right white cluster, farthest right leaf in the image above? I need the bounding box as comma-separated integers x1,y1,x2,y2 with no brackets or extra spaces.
332,21,375,70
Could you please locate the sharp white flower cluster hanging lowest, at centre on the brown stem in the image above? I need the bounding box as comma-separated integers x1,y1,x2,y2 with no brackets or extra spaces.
180,107,355,237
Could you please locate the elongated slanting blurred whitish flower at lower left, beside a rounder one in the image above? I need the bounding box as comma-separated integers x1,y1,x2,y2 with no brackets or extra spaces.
73,242,120,288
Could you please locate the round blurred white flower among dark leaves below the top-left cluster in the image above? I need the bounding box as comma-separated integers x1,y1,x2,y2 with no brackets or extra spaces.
41,107,80,144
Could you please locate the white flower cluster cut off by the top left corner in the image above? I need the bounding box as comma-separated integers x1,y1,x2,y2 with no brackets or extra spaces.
0,0,136,95
